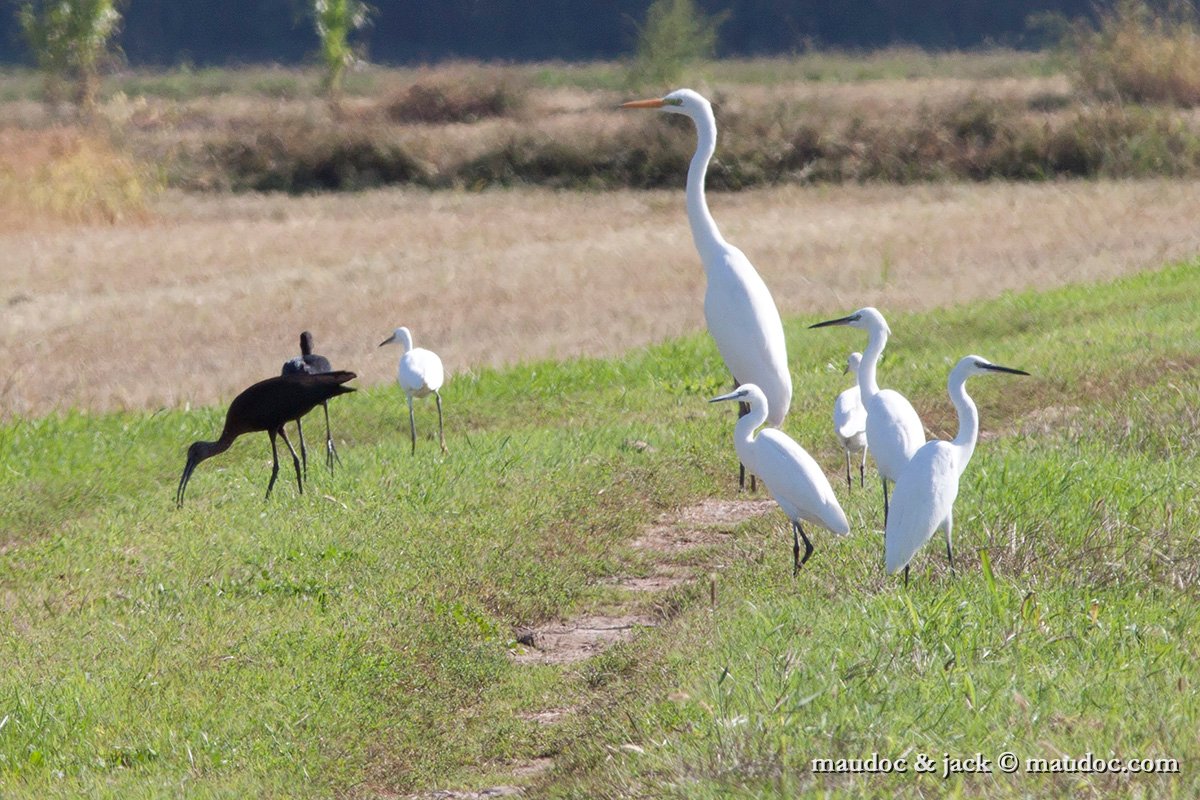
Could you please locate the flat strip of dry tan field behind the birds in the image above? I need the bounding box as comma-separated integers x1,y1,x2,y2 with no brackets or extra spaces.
0,176,1200,415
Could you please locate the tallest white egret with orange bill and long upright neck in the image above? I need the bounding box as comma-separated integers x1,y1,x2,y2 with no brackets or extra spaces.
622,89,792,488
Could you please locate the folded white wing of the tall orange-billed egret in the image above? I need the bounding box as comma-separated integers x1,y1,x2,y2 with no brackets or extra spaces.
702,245,792,426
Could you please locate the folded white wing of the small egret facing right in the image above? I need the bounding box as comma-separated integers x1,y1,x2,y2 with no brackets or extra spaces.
883,441,959,575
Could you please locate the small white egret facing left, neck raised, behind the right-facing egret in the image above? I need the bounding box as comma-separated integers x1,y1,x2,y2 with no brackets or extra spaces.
809,307,925,528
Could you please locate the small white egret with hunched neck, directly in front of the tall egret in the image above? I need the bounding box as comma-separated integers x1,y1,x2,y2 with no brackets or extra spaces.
708,384,850,575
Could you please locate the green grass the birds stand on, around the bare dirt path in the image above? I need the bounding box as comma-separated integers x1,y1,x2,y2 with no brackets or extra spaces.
0,263,1200,798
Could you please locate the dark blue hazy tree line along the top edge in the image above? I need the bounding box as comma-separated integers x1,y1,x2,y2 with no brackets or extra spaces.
0,0,1094,66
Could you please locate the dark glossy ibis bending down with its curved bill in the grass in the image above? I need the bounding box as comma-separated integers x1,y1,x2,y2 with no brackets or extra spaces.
175,371,356,507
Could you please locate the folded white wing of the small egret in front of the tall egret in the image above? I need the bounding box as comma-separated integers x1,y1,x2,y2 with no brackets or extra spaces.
754,428,850,536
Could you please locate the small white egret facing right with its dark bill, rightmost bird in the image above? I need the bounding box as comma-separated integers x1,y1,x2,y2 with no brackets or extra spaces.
883,355,1030,584
